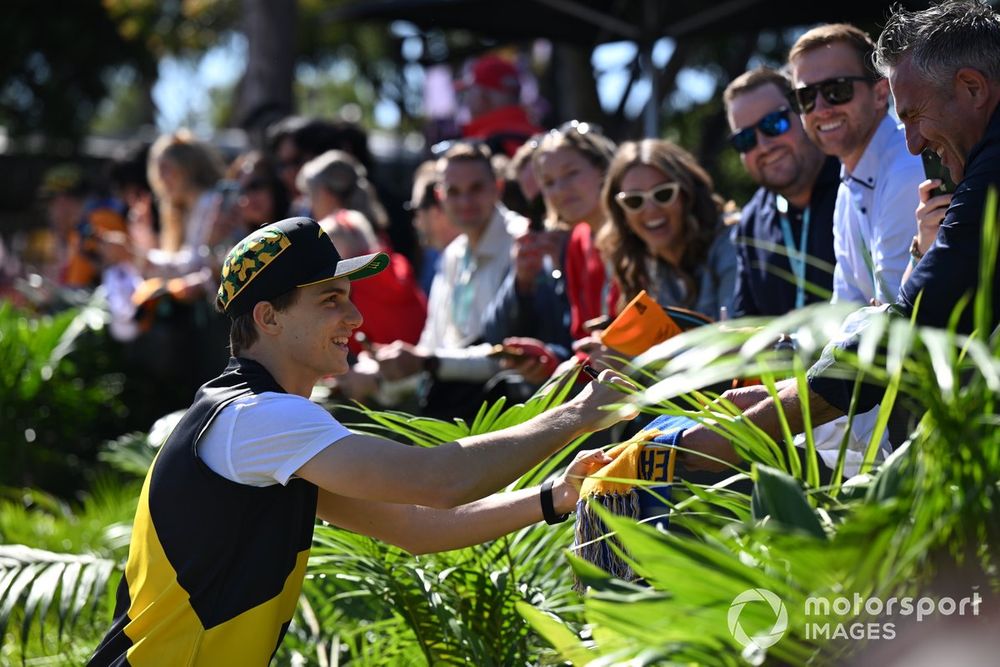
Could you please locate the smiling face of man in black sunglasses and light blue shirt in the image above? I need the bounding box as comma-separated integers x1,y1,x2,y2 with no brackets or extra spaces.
790,42,889,170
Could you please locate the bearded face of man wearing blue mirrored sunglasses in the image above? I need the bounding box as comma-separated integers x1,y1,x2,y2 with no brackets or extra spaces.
728,83,823,199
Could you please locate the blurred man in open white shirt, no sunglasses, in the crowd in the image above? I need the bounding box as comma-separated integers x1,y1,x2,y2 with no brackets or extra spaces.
375,143,527,416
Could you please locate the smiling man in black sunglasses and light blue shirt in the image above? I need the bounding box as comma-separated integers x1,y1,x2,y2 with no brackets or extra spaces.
788,23,924,303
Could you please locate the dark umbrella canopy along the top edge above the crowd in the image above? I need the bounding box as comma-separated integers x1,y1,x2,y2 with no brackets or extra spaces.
331,0,930,45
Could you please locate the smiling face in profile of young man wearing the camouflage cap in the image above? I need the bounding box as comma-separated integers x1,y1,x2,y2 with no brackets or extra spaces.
274,278,362,380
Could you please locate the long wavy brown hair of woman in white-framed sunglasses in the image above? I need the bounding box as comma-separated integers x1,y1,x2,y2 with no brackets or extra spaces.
596,139,722,308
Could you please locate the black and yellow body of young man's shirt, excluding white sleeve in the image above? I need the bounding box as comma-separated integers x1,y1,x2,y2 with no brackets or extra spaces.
90,359,317,667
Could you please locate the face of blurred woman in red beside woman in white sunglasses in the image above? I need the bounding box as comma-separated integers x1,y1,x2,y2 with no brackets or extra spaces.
536,147,604,224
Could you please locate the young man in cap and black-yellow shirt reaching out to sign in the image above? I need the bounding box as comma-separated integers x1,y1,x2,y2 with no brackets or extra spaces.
90,218,636,666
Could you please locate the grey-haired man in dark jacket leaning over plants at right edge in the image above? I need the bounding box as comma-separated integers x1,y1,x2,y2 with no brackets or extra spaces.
683,0,1000,468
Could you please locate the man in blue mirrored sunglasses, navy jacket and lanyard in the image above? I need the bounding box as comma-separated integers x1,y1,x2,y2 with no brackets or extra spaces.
722,67,840,317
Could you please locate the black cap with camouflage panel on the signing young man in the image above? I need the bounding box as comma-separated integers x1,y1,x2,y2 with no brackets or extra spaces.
218,218,389,318
